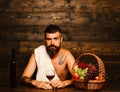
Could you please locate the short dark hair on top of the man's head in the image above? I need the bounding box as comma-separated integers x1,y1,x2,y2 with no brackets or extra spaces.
44,24,62,35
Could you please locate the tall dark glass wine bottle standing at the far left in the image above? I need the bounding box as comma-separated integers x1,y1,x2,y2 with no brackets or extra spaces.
10,49,17,88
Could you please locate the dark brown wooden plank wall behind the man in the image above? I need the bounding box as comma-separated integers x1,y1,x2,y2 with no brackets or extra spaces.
0,0,120,81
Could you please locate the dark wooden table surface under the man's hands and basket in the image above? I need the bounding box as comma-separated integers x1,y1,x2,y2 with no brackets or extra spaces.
0,79,120,92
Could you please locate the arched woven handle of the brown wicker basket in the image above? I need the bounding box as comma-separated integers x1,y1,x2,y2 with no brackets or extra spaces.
76,53,106,79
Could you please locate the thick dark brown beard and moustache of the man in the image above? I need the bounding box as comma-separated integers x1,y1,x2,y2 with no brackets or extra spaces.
46,44,60,58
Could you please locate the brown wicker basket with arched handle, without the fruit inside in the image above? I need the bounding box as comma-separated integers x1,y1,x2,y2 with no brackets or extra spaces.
73,53,106,90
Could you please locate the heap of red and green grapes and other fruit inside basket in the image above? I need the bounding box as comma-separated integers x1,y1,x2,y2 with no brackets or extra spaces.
73,62,98,82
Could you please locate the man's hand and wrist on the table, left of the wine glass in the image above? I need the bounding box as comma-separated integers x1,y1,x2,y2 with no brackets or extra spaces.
32,80,53,89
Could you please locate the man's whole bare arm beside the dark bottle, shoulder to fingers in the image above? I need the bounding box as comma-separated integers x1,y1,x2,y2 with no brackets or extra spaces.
21,53,52,89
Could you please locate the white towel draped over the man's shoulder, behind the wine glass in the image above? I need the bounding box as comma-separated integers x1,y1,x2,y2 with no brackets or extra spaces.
34,45,59,81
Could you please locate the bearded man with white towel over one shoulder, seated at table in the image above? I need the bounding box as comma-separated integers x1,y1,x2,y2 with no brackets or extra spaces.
21,24,75,89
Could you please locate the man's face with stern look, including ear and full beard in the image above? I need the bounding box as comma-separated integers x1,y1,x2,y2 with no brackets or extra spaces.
45,32,62,57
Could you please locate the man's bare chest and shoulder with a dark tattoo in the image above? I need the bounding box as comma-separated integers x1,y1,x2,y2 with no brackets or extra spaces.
52,49,73,80
